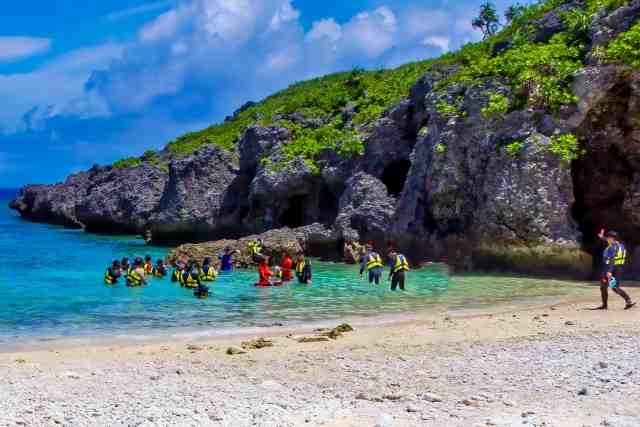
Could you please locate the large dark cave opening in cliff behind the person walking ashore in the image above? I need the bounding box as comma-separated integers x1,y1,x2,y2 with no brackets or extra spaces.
571,80,640,275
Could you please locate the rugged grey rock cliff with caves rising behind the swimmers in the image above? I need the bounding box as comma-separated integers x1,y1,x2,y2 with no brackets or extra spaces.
11,0,640,277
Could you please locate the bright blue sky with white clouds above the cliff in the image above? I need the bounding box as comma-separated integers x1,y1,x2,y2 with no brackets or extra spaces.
0,0,506,187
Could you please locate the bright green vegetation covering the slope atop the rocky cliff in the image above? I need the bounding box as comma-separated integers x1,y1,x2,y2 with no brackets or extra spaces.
114,0,640,168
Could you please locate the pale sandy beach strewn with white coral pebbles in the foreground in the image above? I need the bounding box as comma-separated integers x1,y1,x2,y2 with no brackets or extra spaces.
0,288,640,427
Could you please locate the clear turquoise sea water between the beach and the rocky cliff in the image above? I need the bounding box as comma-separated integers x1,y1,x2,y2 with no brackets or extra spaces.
0,192,592,341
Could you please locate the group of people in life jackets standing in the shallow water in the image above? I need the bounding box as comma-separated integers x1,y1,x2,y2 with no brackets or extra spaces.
104,239,409,298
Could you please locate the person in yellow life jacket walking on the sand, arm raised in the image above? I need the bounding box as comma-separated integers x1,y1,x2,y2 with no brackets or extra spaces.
596,229,636,310
